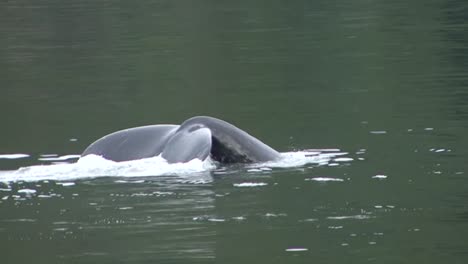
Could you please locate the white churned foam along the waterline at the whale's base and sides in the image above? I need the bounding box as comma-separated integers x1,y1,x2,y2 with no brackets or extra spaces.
0,149,349,183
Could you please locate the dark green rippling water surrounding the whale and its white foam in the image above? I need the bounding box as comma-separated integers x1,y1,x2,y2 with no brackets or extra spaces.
0,0,468,263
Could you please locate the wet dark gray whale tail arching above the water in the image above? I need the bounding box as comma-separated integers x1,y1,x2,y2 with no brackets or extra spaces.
81,116,280,163
